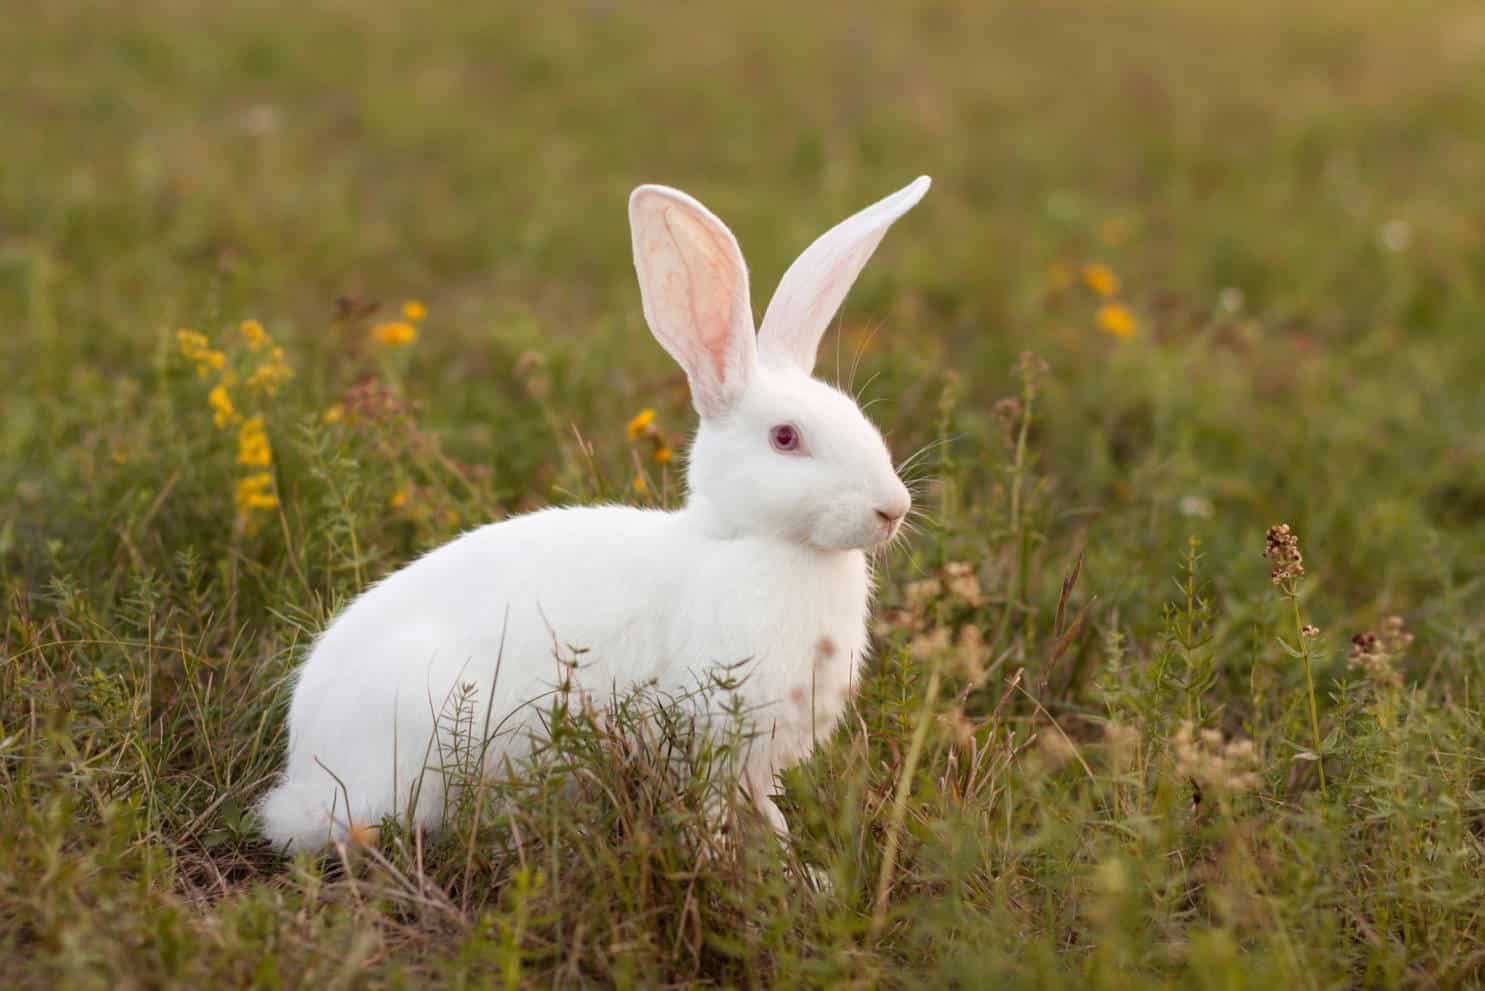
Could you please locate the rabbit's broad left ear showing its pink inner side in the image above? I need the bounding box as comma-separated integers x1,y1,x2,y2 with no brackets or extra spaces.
630,186,757,417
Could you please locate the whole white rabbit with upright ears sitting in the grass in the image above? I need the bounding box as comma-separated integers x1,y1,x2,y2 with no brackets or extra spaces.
260,177,930,848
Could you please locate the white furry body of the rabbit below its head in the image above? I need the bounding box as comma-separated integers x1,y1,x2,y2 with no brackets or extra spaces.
263,507,869,847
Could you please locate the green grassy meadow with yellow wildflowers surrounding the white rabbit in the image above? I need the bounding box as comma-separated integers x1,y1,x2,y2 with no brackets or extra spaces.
0,0,1485,988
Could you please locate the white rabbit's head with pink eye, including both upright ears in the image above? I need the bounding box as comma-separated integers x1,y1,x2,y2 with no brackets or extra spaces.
630,175,928,550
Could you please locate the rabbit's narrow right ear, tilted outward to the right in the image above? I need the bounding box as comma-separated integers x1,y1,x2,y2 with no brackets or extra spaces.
757,175,931,374
